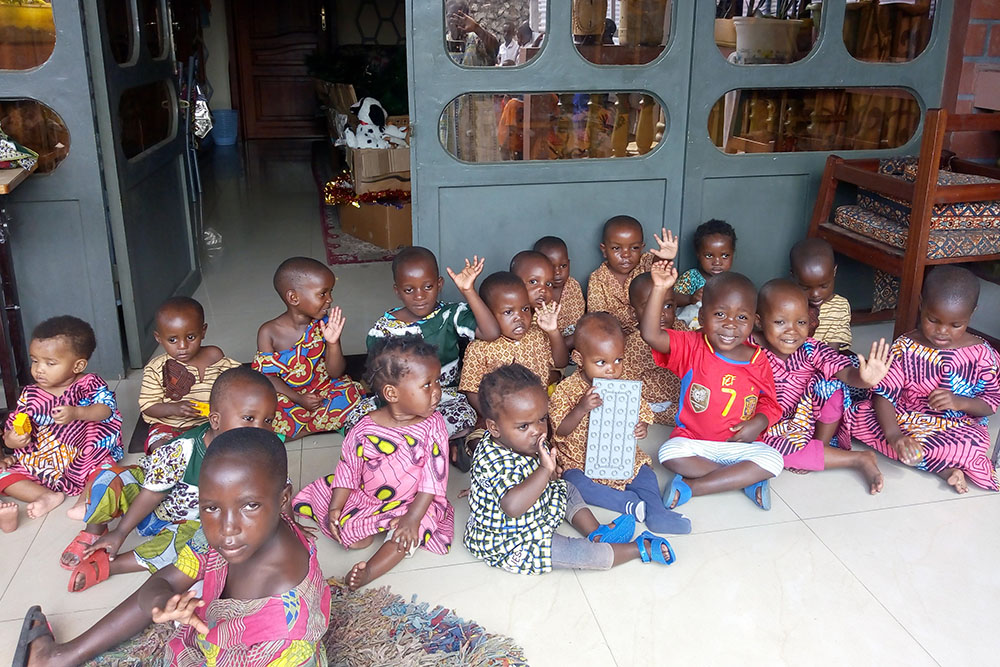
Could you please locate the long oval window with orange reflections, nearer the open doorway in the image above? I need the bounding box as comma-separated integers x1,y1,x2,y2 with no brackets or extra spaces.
439,91,667,162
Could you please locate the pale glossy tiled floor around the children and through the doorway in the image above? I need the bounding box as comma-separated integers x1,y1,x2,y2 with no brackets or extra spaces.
0,144,1000,665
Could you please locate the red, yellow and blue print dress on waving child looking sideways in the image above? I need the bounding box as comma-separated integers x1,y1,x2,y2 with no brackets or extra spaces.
253,317,361,439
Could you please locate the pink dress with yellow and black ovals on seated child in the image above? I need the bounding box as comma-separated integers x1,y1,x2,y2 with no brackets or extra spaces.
294,412,455,554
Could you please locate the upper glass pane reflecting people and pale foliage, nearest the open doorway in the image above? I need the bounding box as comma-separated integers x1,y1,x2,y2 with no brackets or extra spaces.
442,0,546,67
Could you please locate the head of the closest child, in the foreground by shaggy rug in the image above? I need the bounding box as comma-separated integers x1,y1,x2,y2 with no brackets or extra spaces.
198,428,292,564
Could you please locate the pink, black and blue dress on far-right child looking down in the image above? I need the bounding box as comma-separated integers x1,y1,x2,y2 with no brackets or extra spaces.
849,335,1000,491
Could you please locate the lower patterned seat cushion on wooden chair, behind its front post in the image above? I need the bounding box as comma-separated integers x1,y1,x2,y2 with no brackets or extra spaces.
834,206,1000,259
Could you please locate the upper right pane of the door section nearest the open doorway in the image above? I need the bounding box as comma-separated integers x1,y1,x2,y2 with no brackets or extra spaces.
572,0,671,65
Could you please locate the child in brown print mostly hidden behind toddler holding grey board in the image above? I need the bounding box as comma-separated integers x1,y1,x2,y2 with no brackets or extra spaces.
623,272,684,425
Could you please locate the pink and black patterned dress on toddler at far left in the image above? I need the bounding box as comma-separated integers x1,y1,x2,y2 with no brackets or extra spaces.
0,373,124,496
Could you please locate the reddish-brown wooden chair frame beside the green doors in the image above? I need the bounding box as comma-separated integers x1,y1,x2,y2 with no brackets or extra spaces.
808,109,1000,336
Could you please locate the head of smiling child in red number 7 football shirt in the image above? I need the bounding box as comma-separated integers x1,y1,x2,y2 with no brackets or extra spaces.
698,271,757,352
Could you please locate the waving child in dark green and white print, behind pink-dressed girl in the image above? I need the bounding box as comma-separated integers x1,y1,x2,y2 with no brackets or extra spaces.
355,246,500,444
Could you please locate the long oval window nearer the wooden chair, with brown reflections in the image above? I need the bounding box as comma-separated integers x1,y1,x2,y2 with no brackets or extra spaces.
708,88,921,153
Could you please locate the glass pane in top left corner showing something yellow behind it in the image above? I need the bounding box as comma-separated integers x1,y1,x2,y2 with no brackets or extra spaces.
0,0,56,69
